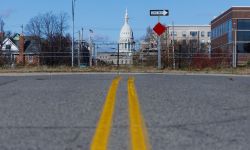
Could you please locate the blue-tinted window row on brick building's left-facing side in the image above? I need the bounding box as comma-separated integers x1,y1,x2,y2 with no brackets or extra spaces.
211,19,232,41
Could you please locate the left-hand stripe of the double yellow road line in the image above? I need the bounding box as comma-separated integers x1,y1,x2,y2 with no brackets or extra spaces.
90,77,121,150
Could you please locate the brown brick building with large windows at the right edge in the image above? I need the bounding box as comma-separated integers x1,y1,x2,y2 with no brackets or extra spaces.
211,6,250,64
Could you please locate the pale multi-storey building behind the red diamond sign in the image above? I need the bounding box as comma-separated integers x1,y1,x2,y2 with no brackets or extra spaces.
140,25,211,60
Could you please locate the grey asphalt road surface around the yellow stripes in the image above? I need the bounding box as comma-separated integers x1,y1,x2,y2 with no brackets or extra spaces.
0,74,250,150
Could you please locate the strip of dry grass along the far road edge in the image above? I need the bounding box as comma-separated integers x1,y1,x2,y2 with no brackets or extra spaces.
0,66,250,75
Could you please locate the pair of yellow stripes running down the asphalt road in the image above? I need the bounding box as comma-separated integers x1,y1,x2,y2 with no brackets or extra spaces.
90,77,151,150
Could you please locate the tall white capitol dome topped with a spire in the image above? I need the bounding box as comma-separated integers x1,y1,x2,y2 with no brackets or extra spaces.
119,10,134,53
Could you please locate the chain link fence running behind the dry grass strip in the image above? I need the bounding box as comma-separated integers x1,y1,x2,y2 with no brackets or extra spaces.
0,48,250,70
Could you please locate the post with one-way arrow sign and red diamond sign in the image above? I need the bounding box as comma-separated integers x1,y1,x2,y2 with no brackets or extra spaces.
150,10,169,69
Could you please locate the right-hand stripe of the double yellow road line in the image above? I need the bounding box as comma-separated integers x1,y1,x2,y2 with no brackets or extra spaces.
128,77,151,150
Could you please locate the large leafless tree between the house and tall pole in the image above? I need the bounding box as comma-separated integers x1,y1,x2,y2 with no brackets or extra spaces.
25,12,71,65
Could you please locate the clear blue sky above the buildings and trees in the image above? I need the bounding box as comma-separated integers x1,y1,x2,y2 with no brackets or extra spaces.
0,0,250,41
